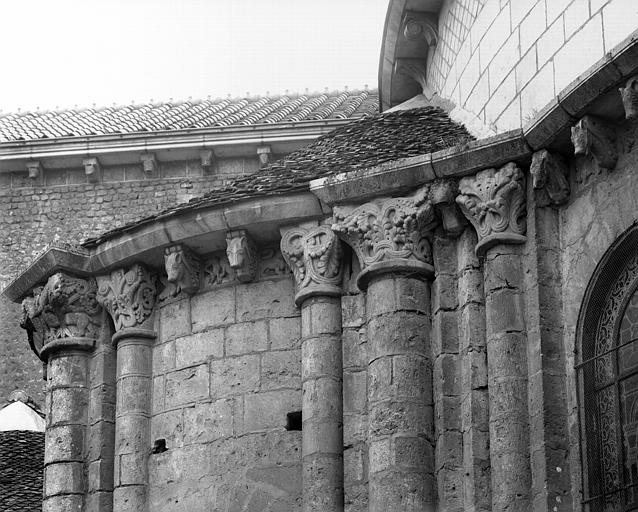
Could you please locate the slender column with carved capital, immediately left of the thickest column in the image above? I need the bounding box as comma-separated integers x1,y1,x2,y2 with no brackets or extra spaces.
281,226,344,512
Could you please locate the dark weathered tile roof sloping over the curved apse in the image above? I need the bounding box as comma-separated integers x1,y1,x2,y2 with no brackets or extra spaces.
83,107,474,247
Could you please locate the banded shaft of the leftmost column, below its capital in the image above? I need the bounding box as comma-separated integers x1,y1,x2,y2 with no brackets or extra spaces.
43,346,89,512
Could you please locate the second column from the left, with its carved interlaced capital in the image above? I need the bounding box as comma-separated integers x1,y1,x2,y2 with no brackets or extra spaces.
97,264,157,512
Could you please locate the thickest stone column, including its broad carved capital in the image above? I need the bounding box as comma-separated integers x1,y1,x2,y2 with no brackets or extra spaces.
333,189,436,512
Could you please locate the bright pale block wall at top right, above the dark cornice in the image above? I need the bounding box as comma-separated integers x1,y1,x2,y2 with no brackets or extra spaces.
428,0,638,132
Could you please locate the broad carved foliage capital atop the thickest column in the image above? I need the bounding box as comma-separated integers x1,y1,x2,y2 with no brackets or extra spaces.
332,187,437,287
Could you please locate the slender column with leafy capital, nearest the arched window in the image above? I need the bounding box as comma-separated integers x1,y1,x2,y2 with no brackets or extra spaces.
457,163,532,512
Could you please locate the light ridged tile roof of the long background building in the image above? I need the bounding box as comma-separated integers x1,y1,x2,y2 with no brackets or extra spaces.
0,90,379,143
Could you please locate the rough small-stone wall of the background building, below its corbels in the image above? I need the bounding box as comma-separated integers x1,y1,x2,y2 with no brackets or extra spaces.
0,158,258,407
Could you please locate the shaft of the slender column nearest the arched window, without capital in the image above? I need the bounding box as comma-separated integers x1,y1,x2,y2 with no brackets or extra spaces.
485,244,532,512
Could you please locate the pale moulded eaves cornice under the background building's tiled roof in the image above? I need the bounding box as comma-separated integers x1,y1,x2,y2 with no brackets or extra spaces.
0,118,358,172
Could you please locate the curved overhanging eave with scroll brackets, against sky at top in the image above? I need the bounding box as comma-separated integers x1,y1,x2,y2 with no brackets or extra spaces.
378,0,443,112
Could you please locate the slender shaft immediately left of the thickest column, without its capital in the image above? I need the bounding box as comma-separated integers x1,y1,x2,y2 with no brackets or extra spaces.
301,296,344,512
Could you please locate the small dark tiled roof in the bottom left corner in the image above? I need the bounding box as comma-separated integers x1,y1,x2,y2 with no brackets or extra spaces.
0,430,44,512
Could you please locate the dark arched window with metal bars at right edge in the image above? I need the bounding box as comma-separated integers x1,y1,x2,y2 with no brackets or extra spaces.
576,227,638,512
